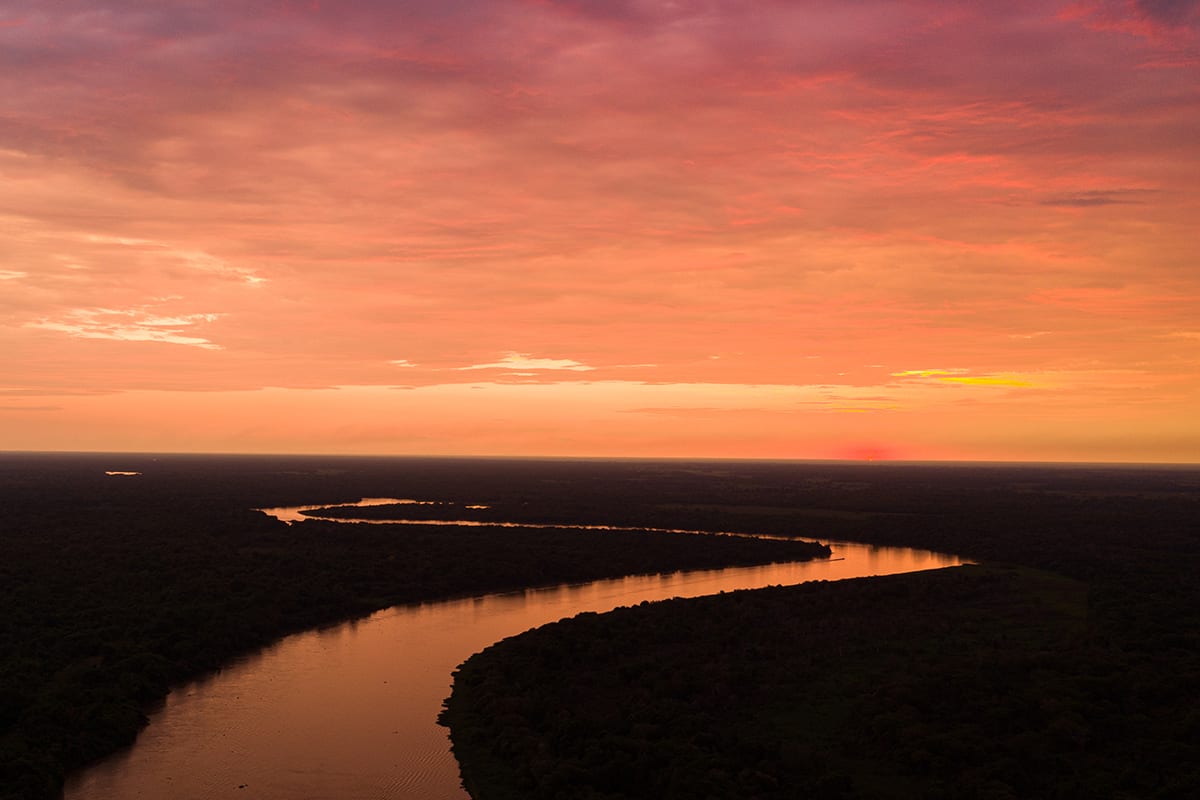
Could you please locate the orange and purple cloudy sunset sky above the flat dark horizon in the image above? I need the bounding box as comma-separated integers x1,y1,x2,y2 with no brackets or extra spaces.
0,0,1200,462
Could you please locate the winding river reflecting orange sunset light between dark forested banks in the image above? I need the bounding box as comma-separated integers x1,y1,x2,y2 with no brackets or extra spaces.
65,499,961,800
